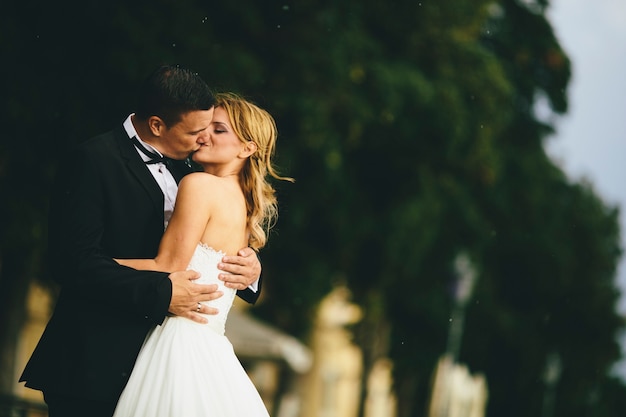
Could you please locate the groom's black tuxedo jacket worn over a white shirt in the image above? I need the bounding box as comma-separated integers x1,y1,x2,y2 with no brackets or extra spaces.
20,126,258,401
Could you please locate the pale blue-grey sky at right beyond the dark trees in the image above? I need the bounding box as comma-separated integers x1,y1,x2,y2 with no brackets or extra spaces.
548,0,626,380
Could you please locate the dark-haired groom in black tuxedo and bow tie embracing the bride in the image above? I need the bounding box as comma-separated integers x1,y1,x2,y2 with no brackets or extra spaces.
20,66,261,417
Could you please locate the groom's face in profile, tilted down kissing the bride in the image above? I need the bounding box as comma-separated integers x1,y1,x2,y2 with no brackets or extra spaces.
161,108,213,159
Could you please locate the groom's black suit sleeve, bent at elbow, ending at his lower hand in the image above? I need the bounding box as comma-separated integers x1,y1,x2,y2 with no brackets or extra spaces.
49,145,172,324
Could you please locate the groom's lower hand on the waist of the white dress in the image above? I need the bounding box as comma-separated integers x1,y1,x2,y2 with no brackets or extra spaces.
168,271,223,323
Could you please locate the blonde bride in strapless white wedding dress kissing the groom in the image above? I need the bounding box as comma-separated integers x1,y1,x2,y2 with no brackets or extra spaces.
114,93,293,417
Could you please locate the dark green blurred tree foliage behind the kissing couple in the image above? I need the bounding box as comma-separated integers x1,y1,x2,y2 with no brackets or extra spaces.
0,0,624,417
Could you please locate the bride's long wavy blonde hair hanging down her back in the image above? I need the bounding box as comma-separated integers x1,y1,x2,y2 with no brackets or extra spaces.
215,93,294,250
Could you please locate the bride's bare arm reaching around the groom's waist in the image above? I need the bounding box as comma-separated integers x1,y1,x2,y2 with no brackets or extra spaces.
116,174,211,272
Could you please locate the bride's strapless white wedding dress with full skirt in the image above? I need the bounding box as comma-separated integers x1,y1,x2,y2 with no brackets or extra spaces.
114,244,269,417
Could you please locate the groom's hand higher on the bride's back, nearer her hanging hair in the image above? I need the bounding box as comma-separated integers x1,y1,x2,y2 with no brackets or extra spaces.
217,248,261,290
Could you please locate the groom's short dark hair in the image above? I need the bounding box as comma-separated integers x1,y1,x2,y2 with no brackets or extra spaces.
135,65,215,127
